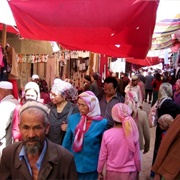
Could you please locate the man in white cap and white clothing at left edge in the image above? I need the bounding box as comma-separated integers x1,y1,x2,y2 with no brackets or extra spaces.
0,81,19,157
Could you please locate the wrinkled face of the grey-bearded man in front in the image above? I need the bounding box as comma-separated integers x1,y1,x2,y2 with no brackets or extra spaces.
19,109,49,155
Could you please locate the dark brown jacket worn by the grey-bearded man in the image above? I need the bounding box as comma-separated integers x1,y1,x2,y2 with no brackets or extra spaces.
0,140,78,180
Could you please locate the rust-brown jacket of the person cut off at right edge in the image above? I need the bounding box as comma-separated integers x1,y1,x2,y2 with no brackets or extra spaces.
152,115,180,180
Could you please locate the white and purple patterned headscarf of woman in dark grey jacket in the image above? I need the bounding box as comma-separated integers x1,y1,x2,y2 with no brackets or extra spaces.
51,78,77,100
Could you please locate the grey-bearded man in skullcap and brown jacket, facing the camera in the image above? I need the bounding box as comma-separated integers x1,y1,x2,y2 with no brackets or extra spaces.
0,100,77,180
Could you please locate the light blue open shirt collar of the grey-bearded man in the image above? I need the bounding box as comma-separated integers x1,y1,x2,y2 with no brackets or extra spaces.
19,140,47,176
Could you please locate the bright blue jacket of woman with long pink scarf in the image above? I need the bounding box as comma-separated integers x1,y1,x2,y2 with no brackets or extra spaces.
62,113,108,173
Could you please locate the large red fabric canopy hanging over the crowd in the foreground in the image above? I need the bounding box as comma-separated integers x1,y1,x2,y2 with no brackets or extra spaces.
9,0,159,58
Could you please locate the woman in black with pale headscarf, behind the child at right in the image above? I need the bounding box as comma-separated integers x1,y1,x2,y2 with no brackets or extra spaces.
151,83,180,177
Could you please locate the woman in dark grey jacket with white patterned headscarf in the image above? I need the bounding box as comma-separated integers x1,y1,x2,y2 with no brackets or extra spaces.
47,79,79,145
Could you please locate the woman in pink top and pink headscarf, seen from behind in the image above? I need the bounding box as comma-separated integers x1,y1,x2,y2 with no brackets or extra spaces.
97,103,141,180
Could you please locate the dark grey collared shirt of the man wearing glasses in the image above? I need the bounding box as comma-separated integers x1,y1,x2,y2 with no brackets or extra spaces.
99,93,120,128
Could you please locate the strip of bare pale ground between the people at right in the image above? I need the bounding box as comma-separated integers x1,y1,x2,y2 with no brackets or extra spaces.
140,103,155,180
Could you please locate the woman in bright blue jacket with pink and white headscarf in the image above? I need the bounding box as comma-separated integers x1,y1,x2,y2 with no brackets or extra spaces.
62,91,108,180
